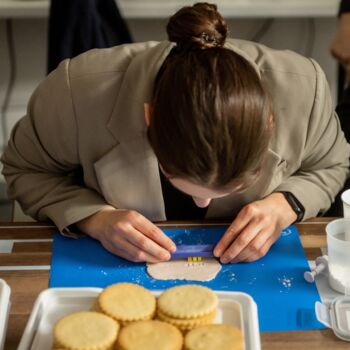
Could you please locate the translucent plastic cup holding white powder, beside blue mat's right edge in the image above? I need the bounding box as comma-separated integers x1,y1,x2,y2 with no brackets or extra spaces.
326,218,350,295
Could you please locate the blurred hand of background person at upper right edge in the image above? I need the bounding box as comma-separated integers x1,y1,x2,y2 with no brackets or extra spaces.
331,13,350,83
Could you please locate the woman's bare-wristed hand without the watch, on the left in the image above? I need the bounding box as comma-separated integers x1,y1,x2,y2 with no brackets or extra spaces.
76,206,176,262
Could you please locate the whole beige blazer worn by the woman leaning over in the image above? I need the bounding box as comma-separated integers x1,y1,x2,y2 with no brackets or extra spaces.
2,40,350,232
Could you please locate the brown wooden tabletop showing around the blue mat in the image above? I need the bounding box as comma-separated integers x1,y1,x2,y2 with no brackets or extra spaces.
0,218,350,350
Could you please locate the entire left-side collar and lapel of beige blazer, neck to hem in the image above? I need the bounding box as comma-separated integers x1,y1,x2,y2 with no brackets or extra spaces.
94,42,173,221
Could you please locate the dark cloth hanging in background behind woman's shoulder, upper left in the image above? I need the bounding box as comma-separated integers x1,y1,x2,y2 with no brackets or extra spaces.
47,0,132,73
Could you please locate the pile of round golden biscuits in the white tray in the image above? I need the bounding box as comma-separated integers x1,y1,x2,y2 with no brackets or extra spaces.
54,283,243,350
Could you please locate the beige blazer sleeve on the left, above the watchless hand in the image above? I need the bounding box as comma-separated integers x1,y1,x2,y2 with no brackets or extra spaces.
1,60,106,232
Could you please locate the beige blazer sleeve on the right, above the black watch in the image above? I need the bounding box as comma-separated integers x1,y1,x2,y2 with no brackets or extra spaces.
275,60,350,219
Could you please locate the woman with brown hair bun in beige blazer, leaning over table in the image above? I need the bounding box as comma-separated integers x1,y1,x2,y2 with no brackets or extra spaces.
2,3,349,263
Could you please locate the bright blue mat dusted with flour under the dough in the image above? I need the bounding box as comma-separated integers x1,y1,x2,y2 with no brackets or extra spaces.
50,226,324,332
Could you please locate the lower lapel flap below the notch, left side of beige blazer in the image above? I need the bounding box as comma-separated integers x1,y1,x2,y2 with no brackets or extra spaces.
94,135,166,221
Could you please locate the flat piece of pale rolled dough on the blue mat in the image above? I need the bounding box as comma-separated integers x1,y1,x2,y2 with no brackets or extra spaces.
147,259,221,282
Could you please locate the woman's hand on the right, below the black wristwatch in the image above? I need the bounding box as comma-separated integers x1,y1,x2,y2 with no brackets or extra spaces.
214,192,297,264
